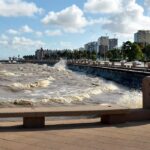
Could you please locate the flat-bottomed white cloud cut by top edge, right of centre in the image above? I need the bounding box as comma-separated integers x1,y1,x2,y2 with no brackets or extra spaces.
84,0,122,13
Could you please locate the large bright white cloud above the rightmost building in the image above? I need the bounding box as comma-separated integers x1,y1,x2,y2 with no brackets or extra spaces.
103,0,150,34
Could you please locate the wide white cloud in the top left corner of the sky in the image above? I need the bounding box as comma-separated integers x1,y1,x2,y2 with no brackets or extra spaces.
0,0,43,17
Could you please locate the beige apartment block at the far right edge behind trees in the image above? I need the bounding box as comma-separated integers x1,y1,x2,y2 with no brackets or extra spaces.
134,30,150,46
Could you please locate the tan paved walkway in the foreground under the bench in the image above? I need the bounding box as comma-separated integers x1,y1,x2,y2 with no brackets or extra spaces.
0,119,150,150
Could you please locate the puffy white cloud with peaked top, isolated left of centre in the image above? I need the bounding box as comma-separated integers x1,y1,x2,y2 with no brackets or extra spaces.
42,5,87,32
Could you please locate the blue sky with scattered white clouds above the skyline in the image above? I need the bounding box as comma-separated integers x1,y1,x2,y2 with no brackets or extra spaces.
0,0,150,59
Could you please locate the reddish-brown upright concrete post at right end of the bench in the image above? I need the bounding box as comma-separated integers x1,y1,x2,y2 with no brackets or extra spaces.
142,76,150,109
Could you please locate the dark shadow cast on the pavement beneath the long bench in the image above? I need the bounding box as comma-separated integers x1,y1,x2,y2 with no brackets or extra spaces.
0,121,150,132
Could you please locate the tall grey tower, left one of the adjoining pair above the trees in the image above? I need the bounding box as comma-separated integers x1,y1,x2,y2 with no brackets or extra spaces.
97,36,109,55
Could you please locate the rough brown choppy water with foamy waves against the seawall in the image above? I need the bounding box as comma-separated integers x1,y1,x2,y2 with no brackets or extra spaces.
0,60,142,108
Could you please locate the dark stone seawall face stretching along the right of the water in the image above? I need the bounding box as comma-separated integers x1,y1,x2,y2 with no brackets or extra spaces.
67,64,150,89
